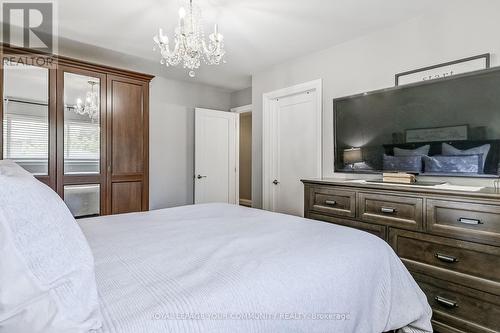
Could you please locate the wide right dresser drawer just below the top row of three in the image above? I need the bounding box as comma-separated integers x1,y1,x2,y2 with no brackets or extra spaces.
389,228,500,295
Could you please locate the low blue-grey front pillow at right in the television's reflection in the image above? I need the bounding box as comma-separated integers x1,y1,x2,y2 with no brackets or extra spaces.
423,155,483,174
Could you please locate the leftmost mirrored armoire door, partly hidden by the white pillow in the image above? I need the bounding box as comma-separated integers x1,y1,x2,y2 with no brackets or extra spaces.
0,59,56,188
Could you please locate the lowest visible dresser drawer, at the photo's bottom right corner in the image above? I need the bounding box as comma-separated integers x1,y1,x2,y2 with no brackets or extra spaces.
412,272,500,333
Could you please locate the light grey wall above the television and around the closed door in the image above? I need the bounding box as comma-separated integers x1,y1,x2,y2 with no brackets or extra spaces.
252,0,500,207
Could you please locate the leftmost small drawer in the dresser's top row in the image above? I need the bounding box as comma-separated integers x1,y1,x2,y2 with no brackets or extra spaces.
309,186,356,217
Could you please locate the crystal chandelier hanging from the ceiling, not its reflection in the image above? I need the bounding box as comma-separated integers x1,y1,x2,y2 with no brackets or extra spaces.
153,0,226,77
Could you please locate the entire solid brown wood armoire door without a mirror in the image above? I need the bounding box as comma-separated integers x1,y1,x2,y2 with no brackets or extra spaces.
107,75,149,214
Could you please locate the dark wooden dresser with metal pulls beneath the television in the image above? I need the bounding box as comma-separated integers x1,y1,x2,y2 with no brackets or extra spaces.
302,180,500,333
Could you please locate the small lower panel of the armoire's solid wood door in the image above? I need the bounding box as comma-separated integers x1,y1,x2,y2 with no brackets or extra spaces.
111,182,142,214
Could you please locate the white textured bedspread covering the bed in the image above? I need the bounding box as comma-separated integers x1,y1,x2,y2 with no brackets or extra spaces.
79,204,432,333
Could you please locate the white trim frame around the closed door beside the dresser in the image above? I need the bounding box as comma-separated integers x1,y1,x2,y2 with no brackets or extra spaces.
262,79,323,210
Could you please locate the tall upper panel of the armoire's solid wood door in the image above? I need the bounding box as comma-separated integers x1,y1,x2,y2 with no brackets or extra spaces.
111,79,144,175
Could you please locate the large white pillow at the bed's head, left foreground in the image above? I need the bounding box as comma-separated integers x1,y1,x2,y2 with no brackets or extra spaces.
0,161,102,333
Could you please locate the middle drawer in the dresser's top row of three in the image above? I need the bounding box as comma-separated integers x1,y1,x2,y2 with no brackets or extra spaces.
358,192,423,230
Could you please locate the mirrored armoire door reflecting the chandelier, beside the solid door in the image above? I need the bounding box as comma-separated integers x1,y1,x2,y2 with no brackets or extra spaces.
57,67,106,218
